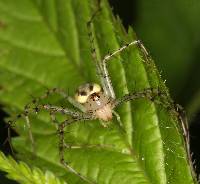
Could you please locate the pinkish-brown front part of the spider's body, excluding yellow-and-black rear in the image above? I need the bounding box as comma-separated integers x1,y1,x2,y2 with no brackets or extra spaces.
84,92,112,121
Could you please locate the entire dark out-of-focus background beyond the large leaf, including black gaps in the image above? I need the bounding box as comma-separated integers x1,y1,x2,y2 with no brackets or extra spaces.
0,0,200,184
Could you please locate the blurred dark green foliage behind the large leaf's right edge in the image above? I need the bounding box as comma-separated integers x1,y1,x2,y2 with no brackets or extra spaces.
135,0,200,119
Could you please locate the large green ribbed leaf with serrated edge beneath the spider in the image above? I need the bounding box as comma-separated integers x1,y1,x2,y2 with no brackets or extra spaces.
0,0,196,184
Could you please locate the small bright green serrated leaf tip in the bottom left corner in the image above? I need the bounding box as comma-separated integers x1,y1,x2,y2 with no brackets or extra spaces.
0,152,66,184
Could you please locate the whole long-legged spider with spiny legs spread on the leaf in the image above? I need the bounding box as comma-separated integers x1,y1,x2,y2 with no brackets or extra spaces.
8,3,190,183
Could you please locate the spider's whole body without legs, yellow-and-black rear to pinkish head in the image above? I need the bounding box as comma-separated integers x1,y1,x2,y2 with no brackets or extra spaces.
75,83,113,121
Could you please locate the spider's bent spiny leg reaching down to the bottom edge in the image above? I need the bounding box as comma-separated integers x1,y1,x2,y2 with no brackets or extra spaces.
58,115,95,184
